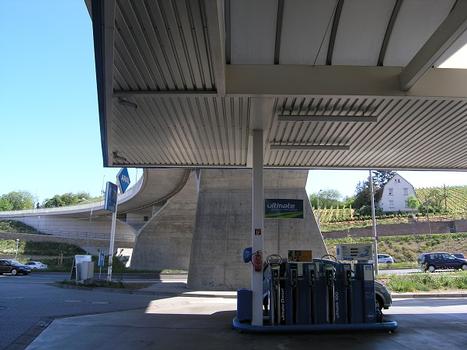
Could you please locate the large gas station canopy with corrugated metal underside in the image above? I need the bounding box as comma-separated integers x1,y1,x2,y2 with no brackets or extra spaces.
87,0,467,170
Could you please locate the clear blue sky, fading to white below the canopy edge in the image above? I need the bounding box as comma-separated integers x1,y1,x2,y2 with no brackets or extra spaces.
0,0,467,202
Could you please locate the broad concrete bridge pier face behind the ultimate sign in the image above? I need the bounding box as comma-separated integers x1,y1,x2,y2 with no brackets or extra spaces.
188,169,326,290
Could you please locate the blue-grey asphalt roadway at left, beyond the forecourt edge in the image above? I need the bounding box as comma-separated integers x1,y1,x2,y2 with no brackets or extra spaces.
0,273,161,349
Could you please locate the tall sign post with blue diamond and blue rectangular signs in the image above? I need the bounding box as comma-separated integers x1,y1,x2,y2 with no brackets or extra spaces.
104,168,130,282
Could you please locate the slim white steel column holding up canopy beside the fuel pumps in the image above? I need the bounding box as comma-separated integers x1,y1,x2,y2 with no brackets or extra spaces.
251,130,264,326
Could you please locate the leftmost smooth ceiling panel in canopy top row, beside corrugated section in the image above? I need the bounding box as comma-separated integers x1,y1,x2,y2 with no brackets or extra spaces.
230,0,277,64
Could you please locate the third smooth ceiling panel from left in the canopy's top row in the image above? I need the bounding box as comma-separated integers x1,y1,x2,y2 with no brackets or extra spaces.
332,0,395,66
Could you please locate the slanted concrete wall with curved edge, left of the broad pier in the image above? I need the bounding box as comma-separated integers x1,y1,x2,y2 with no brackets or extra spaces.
131,172,198,270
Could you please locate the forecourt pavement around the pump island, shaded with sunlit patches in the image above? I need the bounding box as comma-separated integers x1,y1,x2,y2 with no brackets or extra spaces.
24,296,467,350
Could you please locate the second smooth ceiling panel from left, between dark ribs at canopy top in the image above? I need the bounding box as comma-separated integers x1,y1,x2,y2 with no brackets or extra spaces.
279,0,337,65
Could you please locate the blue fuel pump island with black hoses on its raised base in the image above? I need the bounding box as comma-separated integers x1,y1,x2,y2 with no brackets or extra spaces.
233,259,397,333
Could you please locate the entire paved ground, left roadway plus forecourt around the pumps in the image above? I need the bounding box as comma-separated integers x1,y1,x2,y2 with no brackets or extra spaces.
0,273,467,350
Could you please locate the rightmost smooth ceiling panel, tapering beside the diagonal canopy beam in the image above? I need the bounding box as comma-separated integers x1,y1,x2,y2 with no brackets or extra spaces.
384,0,455,67
